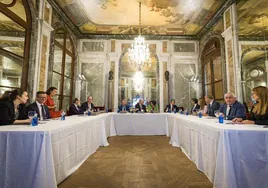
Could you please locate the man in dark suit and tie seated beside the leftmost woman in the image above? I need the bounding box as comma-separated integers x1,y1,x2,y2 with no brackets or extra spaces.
26,91,50,121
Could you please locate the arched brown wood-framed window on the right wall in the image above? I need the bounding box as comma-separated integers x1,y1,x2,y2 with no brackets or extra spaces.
202,38,224,101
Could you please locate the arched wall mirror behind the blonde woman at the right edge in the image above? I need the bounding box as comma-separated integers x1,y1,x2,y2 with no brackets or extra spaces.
241,48,268,102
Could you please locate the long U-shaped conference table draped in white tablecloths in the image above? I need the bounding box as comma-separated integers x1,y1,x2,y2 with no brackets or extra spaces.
0,113,268,188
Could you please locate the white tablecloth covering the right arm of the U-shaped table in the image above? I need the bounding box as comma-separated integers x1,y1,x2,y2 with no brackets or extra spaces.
170,115,268,188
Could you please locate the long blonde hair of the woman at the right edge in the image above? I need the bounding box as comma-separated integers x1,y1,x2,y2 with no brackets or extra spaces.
252,86,268,115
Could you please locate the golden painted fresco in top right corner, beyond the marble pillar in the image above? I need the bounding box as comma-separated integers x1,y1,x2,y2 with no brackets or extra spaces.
237,0,268,37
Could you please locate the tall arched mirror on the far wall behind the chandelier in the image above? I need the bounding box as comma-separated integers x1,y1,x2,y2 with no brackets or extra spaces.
118,49,159,107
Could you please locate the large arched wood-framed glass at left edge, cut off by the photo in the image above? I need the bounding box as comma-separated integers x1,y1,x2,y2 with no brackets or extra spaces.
0,0,31,94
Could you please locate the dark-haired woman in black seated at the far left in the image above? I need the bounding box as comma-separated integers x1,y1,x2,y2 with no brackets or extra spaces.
0,90,31,126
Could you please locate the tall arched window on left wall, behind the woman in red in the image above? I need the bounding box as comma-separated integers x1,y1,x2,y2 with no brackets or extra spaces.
52,29,74,110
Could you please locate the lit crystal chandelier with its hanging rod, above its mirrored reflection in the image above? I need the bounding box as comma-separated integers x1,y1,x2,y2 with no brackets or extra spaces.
128,2,151,70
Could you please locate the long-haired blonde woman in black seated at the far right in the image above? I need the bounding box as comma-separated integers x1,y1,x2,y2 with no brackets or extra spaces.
233,86,268,125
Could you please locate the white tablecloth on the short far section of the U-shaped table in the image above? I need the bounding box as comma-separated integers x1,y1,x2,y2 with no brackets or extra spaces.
111,113,169,136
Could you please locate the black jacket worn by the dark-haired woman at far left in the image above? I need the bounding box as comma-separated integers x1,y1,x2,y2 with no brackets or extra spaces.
0,100,27,126
